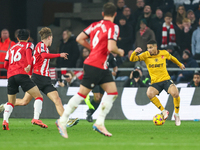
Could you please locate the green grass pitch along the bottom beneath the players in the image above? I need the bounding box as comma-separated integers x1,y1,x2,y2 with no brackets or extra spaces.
0,118,200,150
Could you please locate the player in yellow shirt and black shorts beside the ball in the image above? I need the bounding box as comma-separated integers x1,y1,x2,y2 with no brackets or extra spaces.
130,40,185,126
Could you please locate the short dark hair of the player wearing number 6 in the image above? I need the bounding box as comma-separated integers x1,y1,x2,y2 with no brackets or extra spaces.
103,2,117,17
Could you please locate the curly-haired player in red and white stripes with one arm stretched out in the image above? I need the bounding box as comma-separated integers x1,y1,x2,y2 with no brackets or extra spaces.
1,27,79,128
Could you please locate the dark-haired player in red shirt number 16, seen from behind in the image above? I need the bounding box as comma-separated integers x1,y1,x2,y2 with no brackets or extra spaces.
2,29,47,130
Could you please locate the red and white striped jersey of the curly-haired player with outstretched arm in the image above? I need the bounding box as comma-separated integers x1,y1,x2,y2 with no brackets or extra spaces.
33,41,50,77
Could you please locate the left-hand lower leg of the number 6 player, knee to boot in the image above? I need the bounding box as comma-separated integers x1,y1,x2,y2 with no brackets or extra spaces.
56,85,91,138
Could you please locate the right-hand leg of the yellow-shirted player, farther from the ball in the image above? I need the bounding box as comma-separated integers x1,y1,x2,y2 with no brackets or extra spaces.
168,84,181,126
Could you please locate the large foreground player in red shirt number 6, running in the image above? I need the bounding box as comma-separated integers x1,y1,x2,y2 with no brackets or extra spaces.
56,2,124,138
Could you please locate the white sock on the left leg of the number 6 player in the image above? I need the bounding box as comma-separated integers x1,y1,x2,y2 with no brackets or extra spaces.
60,94,85,126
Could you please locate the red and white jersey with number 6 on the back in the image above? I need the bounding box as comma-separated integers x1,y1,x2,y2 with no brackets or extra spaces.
83,20,119,69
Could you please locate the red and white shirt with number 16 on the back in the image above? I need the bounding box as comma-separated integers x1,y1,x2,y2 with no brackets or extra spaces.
5,42,34,78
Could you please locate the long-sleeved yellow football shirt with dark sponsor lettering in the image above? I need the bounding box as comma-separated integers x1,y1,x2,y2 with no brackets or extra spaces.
130,50,182,84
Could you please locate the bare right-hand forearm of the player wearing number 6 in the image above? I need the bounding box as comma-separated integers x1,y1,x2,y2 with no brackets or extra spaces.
108,40,124,57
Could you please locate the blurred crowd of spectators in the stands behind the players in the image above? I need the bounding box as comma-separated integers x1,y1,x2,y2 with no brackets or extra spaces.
0,0,200,87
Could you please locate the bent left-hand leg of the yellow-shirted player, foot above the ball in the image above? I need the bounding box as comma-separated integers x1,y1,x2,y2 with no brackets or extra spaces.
147,84,169,119
